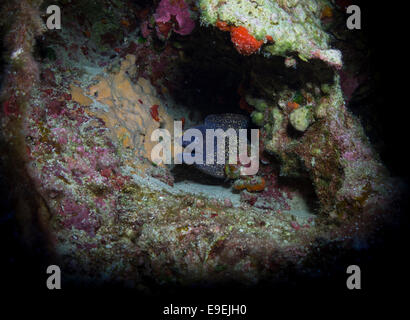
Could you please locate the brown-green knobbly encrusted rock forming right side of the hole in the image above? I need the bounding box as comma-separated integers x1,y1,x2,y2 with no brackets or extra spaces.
247,75,393,215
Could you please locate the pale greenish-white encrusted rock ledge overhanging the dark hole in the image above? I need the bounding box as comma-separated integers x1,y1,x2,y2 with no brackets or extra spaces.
199,0,342,68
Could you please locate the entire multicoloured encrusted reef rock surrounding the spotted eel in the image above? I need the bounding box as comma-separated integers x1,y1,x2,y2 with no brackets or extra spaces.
0,0,400,289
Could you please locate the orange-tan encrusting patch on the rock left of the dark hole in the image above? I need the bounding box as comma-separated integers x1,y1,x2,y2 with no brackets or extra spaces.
87,55,174,162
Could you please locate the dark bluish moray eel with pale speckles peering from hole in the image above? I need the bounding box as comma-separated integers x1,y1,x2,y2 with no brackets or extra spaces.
182,113,249,179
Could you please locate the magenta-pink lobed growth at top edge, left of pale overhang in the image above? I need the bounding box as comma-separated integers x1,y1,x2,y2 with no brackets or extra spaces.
154,0,195,38
